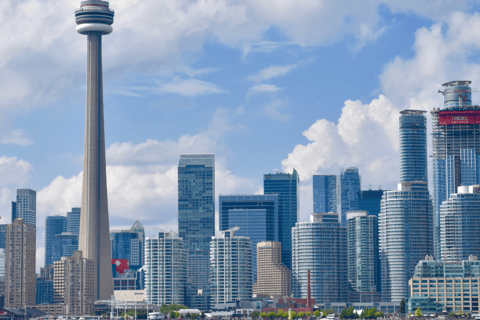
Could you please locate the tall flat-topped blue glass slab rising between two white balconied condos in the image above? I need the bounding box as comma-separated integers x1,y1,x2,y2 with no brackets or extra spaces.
178,154,215,311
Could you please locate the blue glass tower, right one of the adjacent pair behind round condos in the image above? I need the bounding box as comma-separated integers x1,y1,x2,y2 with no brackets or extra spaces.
338,168,362,226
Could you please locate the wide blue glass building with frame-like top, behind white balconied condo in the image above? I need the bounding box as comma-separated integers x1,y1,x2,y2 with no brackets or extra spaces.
218,194,278,282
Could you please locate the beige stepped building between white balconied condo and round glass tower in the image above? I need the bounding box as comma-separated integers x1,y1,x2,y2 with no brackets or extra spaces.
253,241,292,297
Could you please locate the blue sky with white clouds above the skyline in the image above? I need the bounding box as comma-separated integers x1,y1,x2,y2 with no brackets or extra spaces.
0,0,480,269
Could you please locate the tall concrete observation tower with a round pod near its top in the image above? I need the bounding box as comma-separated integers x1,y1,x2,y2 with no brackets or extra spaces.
75,0,113,300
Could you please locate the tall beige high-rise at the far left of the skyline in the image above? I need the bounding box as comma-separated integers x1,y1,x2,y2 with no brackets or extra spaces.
5,218,36,308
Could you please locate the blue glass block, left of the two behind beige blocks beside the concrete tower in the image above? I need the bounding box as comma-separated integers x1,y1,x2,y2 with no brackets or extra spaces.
45,215,67,266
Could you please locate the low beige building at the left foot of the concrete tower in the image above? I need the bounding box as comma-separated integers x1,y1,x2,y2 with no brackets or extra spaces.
53,251,95,316
